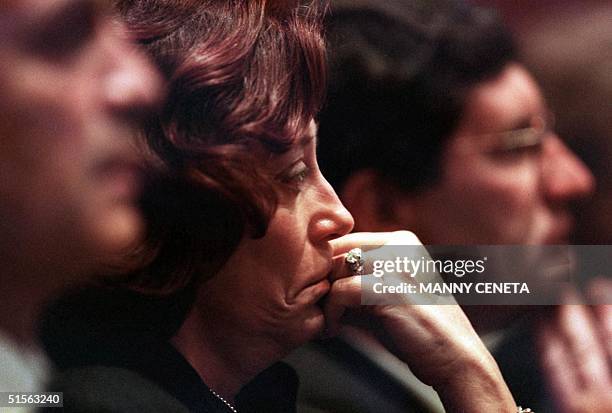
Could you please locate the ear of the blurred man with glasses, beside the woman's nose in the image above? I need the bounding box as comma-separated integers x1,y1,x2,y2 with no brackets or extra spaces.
339,169,416,231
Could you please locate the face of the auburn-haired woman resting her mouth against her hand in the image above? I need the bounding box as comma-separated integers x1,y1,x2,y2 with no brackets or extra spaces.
199,122,354,350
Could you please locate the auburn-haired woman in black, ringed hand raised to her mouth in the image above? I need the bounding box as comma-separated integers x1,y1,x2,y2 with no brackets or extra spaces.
46,0,516,412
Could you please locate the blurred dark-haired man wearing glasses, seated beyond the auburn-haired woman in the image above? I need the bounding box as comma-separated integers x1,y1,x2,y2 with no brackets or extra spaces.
291,0,611,411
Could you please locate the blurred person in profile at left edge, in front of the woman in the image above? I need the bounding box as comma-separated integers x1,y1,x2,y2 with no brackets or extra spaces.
0,0,160,391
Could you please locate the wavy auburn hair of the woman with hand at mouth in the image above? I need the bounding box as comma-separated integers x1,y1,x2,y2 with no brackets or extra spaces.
116,0,327,293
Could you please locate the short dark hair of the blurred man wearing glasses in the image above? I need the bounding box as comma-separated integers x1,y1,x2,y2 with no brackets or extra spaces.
318,0,515,191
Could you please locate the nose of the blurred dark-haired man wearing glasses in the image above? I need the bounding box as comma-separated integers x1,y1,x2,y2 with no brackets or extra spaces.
543,135,595,203
